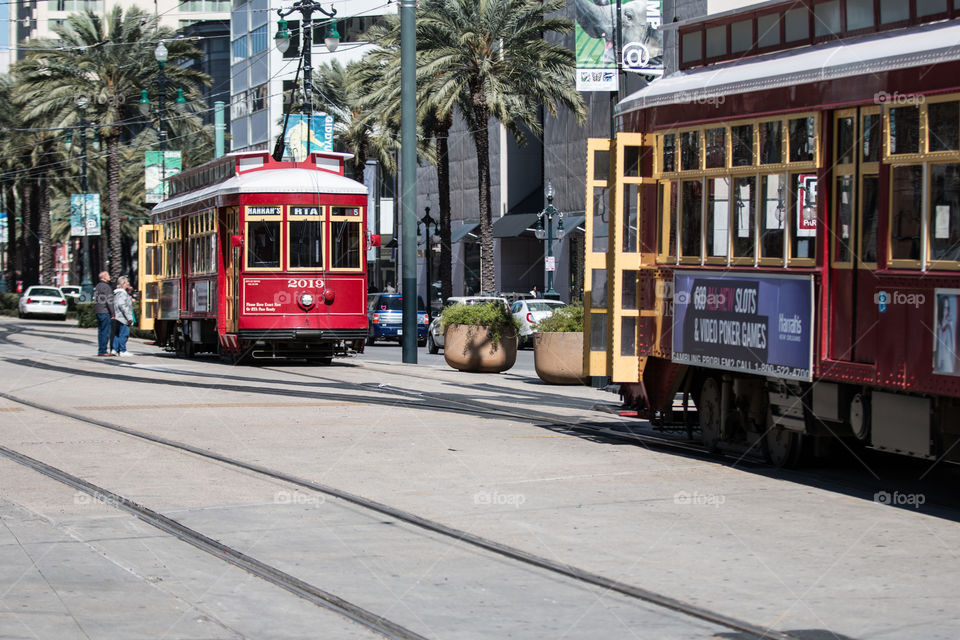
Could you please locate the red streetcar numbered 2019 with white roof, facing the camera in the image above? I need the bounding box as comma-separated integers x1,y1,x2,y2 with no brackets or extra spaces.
139,151,379,362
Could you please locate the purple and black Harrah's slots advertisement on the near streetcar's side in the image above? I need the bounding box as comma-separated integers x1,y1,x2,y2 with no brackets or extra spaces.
673,271,814,380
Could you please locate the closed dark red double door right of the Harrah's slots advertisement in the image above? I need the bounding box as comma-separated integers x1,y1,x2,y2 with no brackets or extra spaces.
827,107,883,364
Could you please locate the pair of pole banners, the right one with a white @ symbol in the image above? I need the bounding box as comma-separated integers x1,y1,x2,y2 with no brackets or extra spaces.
574,0,663,91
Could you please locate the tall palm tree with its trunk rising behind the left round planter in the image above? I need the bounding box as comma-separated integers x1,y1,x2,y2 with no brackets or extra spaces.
417,0,586,291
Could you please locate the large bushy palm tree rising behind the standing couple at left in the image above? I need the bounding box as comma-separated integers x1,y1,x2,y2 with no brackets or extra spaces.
15,6,209,277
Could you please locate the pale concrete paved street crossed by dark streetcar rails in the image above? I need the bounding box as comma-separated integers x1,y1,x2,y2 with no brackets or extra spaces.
0,317,960,640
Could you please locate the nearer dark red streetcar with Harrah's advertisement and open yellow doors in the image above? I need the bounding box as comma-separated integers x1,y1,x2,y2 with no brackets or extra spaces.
584,0,960,464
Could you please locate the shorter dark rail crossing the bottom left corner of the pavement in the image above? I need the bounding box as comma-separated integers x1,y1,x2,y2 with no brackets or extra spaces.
0,445,427,640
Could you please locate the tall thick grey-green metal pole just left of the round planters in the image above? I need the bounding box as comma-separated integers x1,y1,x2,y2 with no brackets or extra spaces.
400,0,417,364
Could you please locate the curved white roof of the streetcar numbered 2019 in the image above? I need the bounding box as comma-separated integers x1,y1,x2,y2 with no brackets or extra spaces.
152,169,367,214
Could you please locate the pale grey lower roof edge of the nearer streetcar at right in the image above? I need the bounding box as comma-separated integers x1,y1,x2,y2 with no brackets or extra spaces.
617,20,960,115
